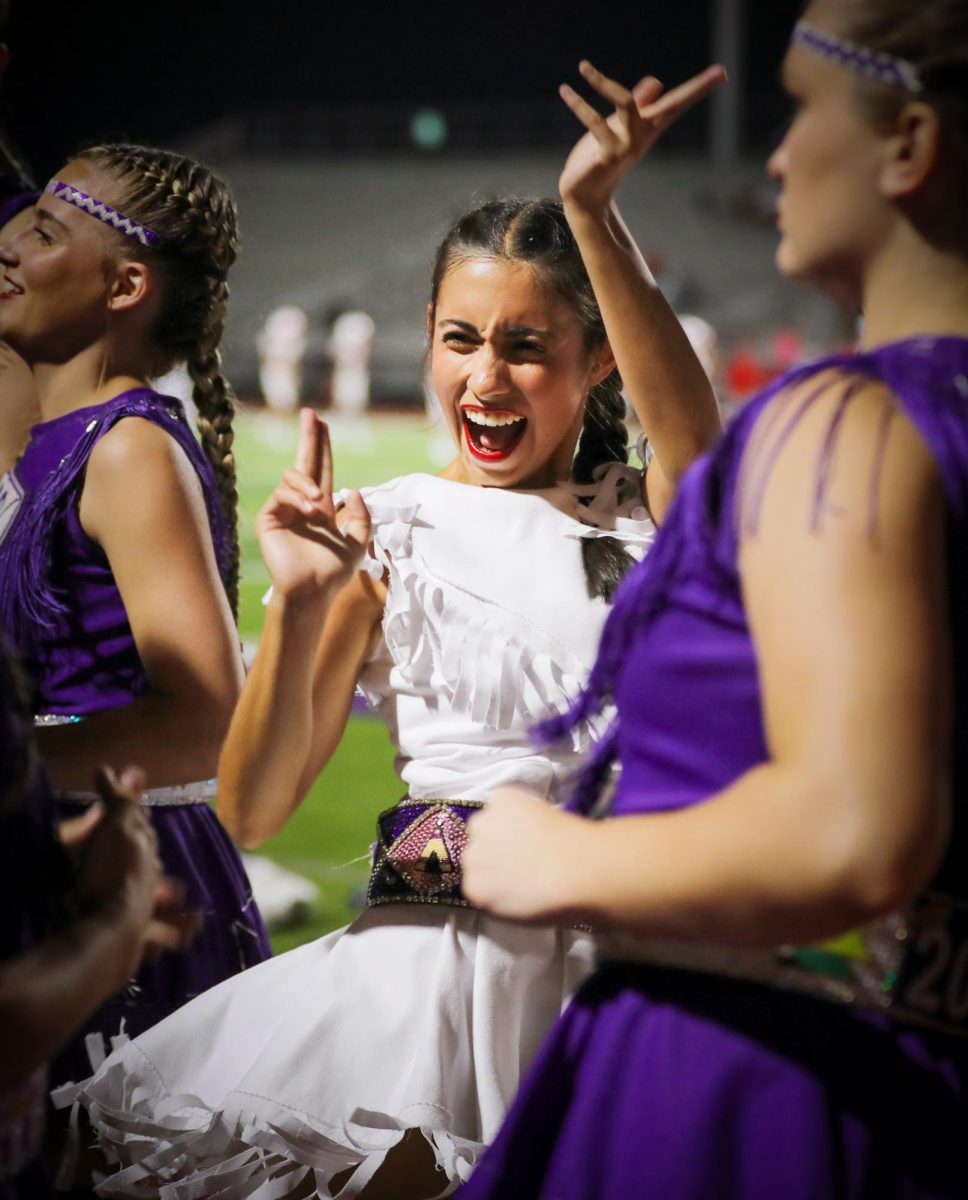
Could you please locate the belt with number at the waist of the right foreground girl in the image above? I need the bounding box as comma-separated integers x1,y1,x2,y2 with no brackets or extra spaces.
596,892,968,1037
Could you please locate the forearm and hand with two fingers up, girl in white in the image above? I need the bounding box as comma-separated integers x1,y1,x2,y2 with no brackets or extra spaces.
218,409,385,846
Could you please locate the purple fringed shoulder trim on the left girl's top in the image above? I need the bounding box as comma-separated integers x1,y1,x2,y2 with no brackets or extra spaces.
0,388,229,644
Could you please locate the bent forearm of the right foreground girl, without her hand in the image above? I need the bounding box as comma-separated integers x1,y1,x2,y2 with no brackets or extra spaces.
560,764,944,946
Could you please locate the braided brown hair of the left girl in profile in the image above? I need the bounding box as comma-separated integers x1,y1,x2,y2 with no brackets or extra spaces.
78,145,239,616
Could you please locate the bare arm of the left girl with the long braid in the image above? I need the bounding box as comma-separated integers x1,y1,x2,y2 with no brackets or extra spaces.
38,418,242,790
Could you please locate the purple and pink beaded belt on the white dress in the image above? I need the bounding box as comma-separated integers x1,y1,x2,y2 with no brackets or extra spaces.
366,798,483,908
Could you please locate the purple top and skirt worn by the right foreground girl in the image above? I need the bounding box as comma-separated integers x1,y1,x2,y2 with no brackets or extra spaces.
461,338,968,1200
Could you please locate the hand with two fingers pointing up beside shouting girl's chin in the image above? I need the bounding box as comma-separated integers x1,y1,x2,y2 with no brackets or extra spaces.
255,408,369,596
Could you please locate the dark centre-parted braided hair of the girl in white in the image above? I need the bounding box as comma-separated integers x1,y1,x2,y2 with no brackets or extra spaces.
431,197,633,600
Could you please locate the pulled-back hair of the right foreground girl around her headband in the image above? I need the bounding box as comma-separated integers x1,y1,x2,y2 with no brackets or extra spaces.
836,0,968,226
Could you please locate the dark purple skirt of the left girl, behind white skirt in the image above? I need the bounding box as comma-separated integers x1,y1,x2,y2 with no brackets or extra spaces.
50,804,272,1086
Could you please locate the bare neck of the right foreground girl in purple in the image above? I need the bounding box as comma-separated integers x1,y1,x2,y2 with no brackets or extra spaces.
861,225,968,349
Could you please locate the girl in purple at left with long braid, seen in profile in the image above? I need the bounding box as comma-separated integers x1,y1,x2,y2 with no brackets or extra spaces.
0,146,269,1080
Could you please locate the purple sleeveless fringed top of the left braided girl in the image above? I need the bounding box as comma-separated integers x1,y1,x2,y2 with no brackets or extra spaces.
0,388,229,715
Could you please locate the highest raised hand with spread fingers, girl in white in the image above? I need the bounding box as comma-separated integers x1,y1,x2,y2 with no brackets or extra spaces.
558,60,726,211
